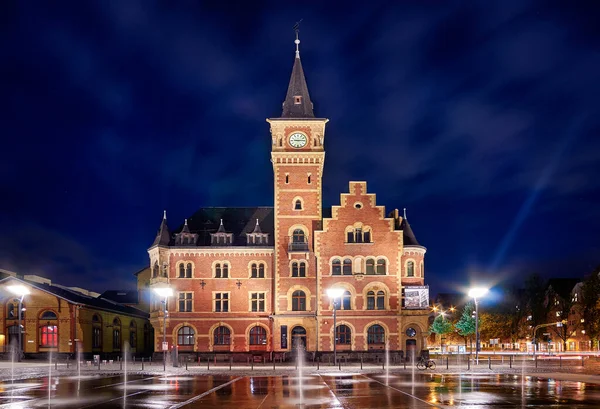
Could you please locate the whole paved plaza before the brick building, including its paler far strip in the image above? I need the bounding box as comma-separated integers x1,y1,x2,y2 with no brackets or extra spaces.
0,362,600,409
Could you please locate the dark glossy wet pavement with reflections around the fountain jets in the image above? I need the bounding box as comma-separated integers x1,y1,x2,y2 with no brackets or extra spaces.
0,372,600,409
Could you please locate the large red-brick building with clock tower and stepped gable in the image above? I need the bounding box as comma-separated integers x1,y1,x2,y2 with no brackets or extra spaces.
142,36,429,358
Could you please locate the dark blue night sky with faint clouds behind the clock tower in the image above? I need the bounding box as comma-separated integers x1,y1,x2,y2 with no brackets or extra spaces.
0,0,600,292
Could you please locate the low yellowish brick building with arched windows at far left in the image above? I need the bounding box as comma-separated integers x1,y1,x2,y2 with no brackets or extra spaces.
0,273,154,359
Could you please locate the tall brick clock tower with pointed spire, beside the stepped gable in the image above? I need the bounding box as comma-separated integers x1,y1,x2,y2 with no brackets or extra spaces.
267,31,328,350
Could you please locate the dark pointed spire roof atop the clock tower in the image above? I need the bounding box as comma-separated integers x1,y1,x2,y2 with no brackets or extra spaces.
281,31,315,118
